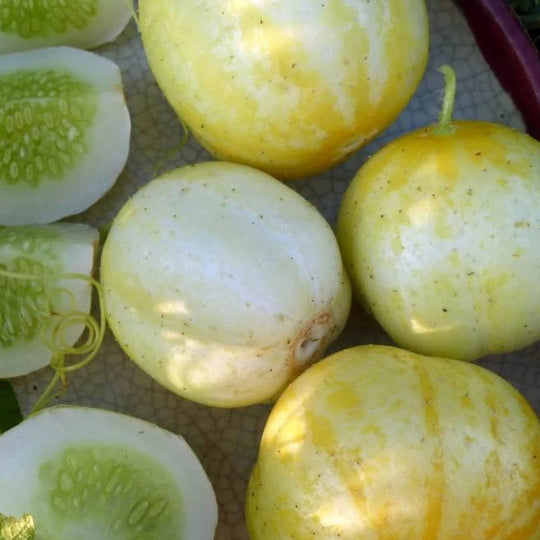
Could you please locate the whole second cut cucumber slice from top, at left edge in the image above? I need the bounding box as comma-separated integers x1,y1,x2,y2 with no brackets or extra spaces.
0,47,131,225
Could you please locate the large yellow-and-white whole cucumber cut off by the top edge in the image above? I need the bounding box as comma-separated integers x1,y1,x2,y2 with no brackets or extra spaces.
138,0,429,180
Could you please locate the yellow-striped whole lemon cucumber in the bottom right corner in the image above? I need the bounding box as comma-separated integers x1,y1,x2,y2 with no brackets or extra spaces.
246,345,540,540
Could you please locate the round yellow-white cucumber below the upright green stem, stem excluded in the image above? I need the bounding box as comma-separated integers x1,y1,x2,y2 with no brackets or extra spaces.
337,120,540,360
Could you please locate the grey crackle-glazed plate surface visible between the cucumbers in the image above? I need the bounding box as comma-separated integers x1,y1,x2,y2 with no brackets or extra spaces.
10,0,540,540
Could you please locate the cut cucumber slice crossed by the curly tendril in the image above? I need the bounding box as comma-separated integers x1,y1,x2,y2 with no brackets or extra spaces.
0,223,99,378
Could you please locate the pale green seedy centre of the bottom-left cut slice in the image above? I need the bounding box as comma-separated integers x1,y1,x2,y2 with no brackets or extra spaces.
35,446,183,540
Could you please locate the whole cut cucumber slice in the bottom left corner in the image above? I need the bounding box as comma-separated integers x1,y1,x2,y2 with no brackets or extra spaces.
0,406,217,540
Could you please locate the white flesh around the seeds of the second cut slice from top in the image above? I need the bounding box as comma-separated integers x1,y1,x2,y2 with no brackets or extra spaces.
0,47,131,225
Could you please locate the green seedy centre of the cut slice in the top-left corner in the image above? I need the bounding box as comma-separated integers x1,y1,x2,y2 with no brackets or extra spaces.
0,0,98,39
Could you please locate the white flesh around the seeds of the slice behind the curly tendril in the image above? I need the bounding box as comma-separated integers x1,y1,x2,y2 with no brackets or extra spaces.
0,223,99,378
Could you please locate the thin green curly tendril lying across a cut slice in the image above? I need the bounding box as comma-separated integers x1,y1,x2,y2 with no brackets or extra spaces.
0,268,106,414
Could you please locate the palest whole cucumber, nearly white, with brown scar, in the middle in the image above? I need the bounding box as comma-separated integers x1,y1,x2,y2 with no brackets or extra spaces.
101,162,351,407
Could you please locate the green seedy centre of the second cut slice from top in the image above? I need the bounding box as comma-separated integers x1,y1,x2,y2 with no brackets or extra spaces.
0,70,97,186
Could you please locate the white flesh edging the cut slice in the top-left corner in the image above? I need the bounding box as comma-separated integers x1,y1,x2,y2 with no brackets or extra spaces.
0,0,132,54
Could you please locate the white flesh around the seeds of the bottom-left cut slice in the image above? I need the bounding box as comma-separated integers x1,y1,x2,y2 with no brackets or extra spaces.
0,406,218,540
